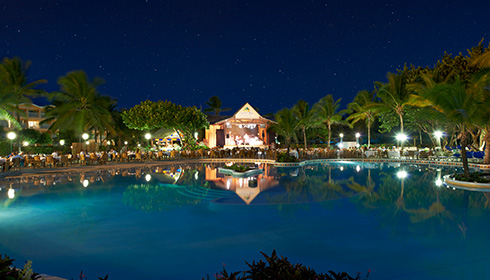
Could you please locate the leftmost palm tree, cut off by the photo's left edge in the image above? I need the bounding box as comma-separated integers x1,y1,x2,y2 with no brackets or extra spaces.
0,57,47,128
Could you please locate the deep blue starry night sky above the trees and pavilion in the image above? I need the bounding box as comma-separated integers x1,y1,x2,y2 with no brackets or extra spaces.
0,0,490,114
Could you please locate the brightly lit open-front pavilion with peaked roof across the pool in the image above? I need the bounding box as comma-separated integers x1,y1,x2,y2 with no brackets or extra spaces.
205,103,275,149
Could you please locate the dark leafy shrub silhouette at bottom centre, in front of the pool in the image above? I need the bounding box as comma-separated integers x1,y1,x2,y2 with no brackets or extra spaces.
203,250,369,280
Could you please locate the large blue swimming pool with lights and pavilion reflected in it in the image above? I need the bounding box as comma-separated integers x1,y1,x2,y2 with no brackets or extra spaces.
0,162,490,279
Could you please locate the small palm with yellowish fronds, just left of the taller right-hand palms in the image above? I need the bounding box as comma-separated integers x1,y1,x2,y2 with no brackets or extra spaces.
347,90,378,149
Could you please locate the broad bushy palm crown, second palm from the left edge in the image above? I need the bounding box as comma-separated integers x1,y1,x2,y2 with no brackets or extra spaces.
45,71,116,142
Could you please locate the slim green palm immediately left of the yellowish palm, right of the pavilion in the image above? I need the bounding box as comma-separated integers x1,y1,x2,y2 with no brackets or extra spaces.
314,94,348,148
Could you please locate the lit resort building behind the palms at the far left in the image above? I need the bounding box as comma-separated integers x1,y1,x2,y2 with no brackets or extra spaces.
0,104,50,132
